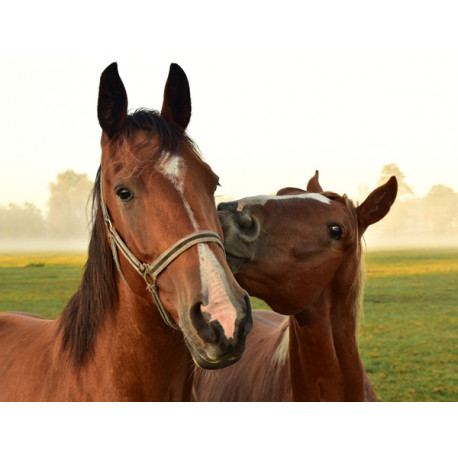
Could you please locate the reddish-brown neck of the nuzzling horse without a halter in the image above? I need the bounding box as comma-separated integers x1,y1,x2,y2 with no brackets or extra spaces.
290,250,365,401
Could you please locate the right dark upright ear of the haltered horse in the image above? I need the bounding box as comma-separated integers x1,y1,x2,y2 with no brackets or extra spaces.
161,64,191,132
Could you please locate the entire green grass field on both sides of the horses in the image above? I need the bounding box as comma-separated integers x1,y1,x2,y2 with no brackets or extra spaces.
0,249,458,401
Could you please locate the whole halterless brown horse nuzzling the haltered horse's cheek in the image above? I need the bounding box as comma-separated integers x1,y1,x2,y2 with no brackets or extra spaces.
194,172,397,401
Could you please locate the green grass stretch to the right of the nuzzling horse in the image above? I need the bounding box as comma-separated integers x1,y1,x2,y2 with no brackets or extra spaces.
359,250,458,401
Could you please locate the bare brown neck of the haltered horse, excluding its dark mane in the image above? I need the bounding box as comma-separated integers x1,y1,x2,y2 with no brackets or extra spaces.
96,275,193,401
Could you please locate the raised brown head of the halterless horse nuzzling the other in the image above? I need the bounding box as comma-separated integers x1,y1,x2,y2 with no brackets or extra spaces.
218,172,397,315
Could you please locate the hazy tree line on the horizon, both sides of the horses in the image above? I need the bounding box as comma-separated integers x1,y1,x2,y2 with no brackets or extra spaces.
0,164,458,243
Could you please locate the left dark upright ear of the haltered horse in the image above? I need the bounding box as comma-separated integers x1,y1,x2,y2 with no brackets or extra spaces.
97,62,127,139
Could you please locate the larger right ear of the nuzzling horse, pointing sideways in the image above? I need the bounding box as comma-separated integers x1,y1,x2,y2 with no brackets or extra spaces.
356,176,398,234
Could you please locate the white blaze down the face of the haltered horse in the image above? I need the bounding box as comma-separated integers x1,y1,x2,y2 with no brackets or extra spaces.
158,152,237,339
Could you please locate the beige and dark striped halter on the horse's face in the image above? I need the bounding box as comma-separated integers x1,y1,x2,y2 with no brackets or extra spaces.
100,174,224,329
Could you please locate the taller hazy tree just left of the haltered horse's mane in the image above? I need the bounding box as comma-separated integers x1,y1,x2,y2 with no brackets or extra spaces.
48,170,94,238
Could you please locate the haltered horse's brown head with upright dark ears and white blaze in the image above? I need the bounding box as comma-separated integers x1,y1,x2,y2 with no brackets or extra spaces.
98,63,252,369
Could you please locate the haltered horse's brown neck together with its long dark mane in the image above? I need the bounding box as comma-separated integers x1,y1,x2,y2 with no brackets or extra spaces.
57,188,193,400
